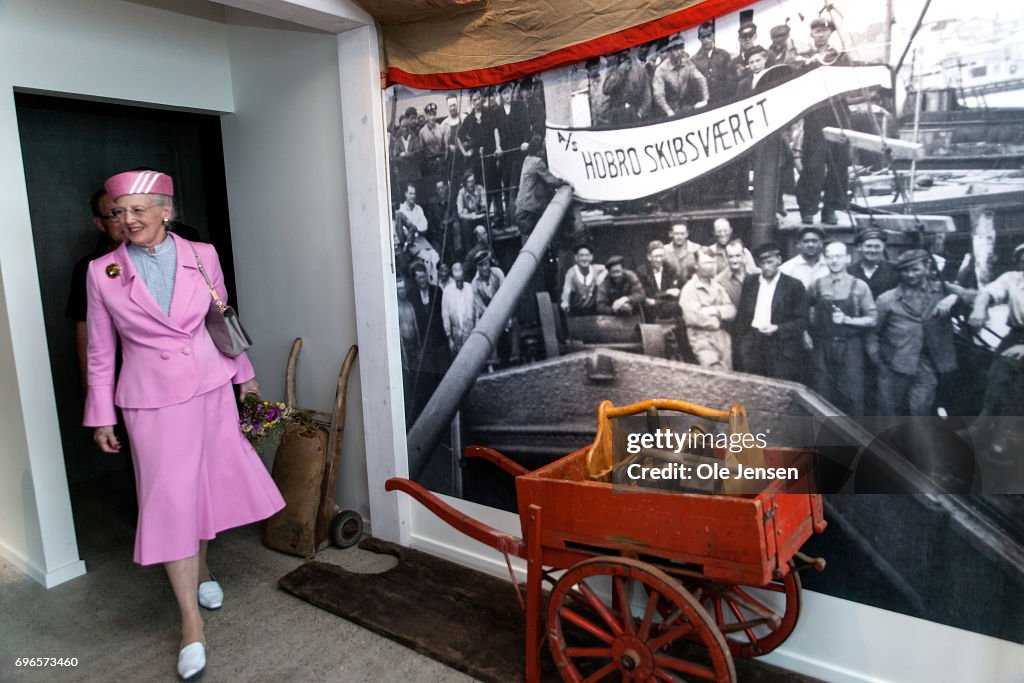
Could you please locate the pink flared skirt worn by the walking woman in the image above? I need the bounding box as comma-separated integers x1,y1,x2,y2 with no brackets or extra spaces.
122,384,285,564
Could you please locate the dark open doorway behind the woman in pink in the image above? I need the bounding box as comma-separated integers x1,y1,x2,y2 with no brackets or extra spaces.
15,93,234,482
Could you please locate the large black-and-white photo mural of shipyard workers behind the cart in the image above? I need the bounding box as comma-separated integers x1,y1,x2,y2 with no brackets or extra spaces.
384,0,1024,642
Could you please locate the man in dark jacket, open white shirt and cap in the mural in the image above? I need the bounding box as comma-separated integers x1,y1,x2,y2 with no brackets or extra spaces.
734,243,808,382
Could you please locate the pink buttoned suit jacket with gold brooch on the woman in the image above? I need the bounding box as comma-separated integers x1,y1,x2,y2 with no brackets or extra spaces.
83,236,255,427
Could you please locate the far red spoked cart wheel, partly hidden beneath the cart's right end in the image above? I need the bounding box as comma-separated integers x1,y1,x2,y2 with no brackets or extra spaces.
694,569,801,657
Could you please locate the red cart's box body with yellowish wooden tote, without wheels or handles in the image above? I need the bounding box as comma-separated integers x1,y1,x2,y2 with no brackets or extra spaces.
516,400,824,585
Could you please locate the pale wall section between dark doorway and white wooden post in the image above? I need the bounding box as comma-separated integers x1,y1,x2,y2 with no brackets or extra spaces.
222,10,370,517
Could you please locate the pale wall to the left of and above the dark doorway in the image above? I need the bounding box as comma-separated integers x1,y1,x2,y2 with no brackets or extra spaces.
0,0,232,586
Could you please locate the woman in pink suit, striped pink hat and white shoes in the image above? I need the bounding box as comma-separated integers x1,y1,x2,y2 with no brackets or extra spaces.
84,171,285,680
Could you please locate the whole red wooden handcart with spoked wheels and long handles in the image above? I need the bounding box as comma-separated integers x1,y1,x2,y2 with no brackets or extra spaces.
386,399,825,683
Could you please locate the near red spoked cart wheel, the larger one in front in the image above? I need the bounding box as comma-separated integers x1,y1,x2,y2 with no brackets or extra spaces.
547,557,736,683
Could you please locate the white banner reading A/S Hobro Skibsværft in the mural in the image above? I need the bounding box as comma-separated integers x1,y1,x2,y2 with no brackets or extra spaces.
546,66,892,202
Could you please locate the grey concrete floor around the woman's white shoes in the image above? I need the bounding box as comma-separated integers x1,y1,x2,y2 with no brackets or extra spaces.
0,485,474,683
